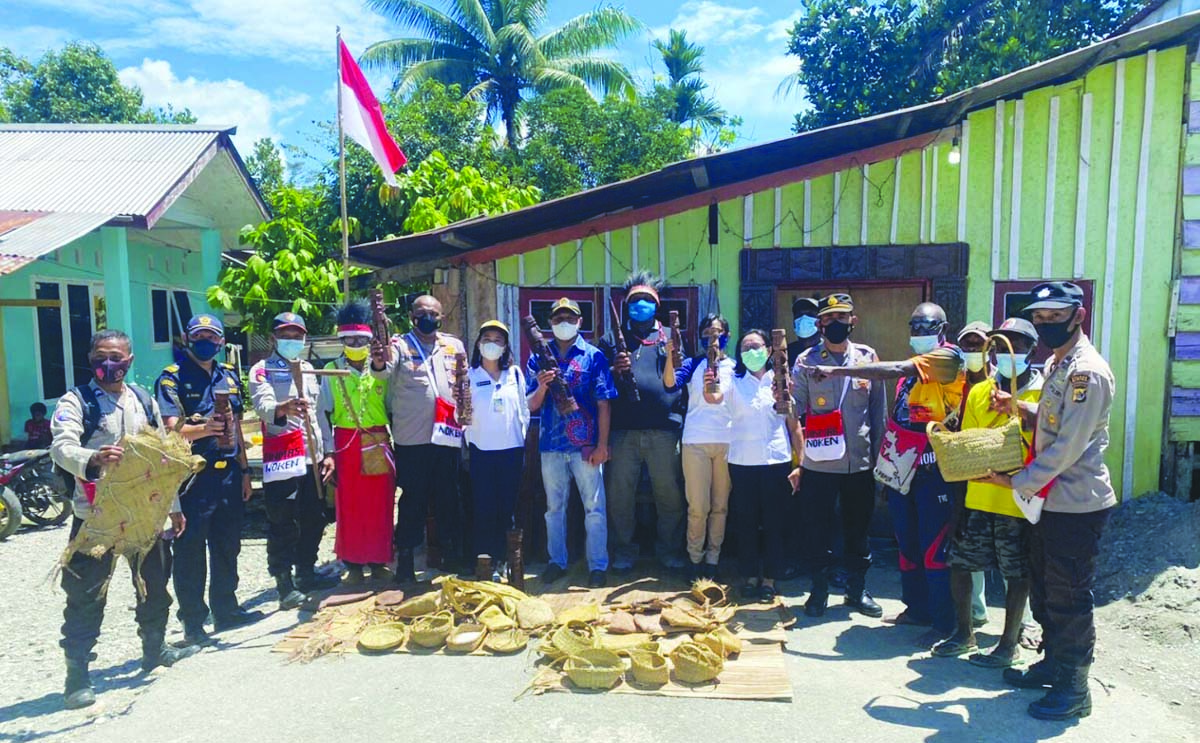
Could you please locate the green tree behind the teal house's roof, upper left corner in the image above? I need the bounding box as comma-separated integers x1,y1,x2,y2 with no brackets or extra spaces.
0,42,196,124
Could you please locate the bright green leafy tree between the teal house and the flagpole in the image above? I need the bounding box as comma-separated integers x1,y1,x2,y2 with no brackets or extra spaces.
208,186,342,335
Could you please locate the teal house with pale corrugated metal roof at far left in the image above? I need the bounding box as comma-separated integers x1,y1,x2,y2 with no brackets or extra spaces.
0,124,268,443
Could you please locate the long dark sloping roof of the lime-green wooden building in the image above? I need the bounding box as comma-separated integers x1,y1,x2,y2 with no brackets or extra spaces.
350,13,1200,273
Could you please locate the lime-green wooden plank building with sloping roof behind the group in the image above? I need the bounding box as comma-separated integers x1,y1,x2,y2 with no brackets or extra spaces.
353,15,1200,496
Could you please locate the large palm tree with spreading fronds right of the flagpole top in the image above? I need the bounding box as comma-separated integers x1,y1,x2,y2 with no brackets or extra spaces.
362,0,642,149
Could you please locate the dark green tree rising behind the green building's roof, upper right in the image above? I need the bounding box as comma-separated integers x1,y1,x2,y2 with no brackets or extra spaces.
781,0,1142,132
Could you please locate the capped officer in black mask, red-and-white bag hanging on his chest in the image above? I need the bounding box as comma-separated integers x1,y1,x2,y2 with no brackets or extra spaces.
792,294,887,617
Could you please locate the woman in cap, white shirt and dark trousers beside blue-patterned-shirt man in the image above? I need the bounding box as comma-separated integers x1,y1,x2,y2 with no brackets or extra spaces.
463,320,529,575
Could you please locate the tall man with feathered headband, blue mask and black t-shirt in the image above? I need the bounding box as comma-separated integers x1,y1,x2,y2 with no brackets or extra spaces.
600,271,684,573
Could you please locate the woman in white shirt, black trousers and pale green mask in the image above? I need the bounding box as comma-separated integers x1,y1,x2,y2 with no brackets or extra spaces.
706,330,804,603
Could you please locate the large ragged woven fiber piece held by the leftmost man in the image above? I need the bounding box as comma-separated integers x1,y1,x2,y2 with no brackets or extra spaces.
60,429,204,595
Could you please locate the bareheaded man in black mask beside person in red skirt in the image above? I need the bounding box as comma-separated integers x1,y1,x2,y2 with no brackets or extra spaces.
371,294,467,583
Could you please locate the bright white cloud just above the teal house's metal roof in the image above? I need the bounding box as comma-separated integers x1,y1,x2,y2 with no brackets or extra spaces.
119,59,308,155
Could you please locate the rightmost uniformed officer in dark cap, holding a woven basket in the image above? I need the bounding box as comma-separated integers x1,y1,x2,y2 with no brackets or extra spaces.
988,281,1116,720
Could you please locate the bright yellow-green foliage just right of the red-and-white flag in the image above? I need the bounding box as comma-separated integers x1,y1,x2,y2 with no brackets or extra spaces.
380,151,541,233
